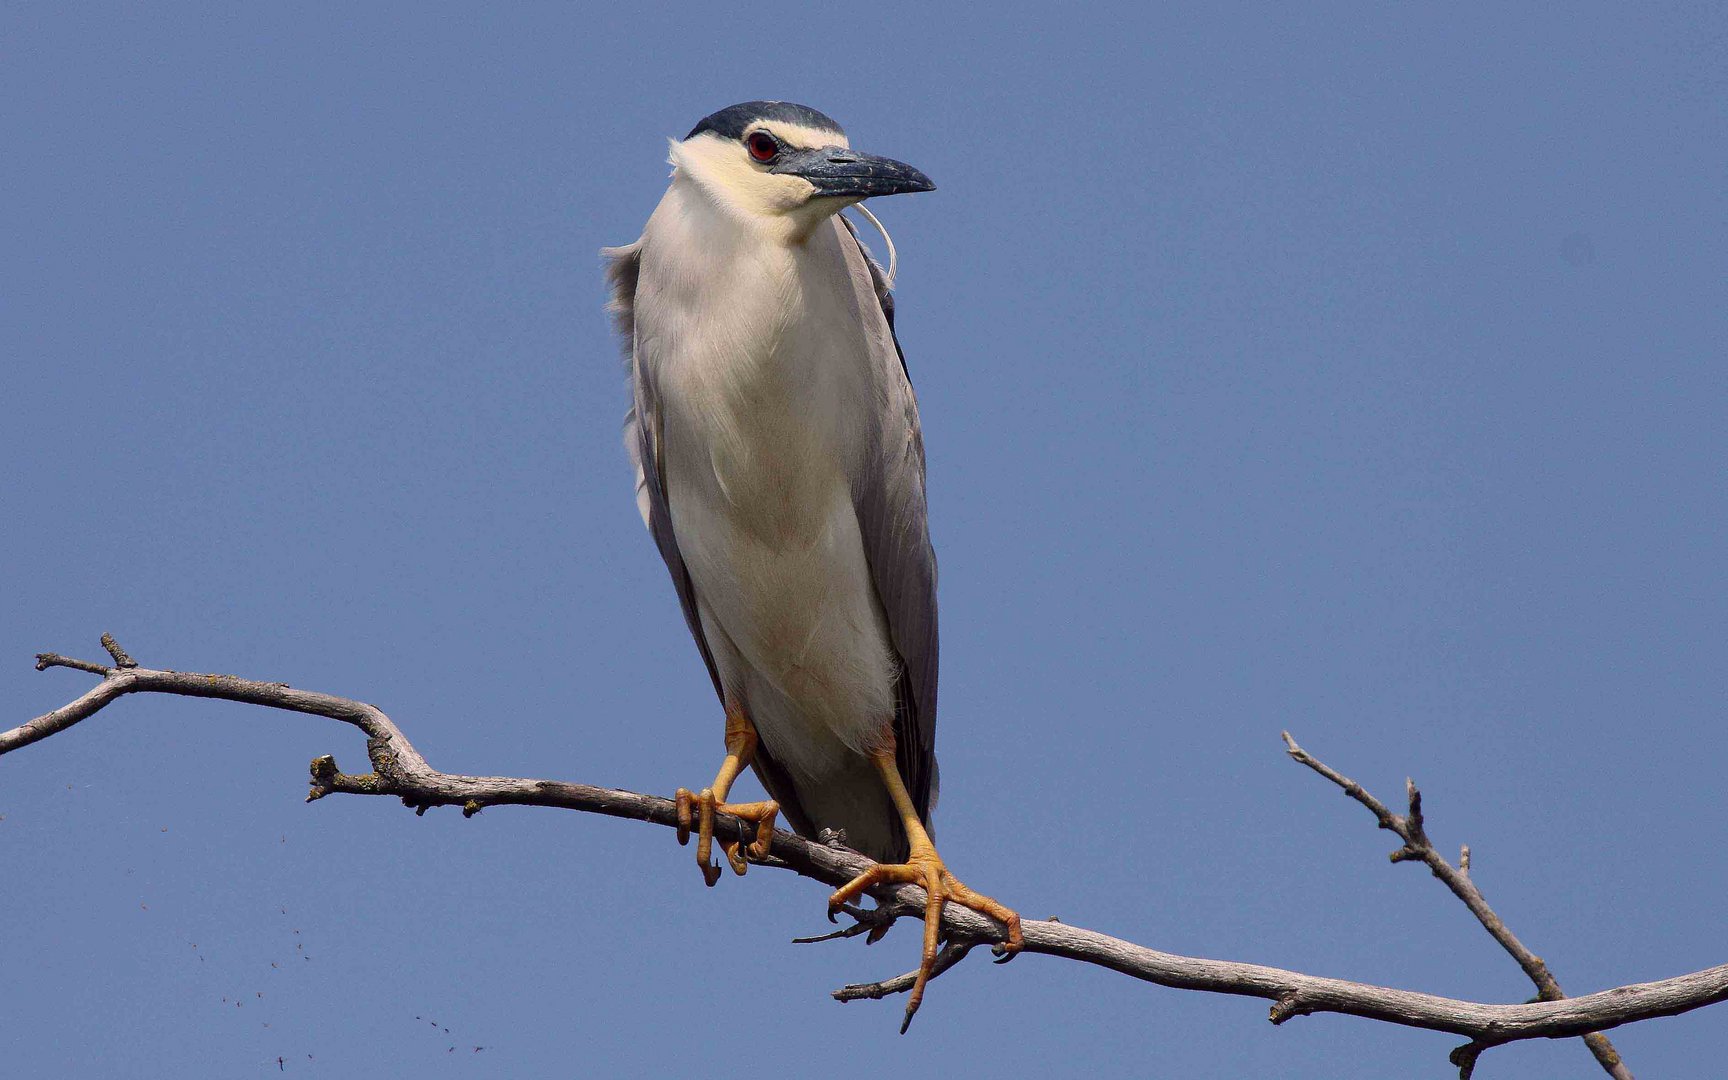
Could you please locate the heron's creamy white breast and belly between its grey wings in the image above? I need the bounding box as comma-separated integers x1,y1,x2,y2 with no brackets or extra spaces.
636,183,893,776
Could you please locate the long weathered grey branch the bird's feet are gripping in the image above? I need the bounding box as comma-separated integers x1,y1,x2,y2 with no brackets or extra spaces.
0,645,1728,1068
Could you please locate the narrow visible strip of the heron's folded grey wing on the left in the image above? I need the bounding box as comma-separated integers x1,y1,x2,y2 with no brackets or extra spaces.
600,240,814,836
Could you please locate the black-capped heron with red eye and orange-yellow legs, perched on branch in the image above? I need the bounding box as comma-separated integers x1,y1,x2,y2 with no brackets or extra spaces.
601,100,1023,1032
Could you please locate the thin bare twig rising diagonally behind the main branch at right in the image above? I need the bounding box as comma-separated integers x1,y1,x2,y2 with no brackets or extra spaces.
1284,731,1633,1080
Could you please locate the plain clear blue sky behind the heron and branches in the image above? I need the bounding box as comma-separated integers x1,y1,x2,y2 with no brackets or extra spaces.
0,3,1728,1078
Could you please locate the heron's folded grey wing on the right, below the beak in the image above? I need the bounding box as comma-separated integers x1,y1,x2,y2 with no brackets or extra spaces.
836,214,940,828
